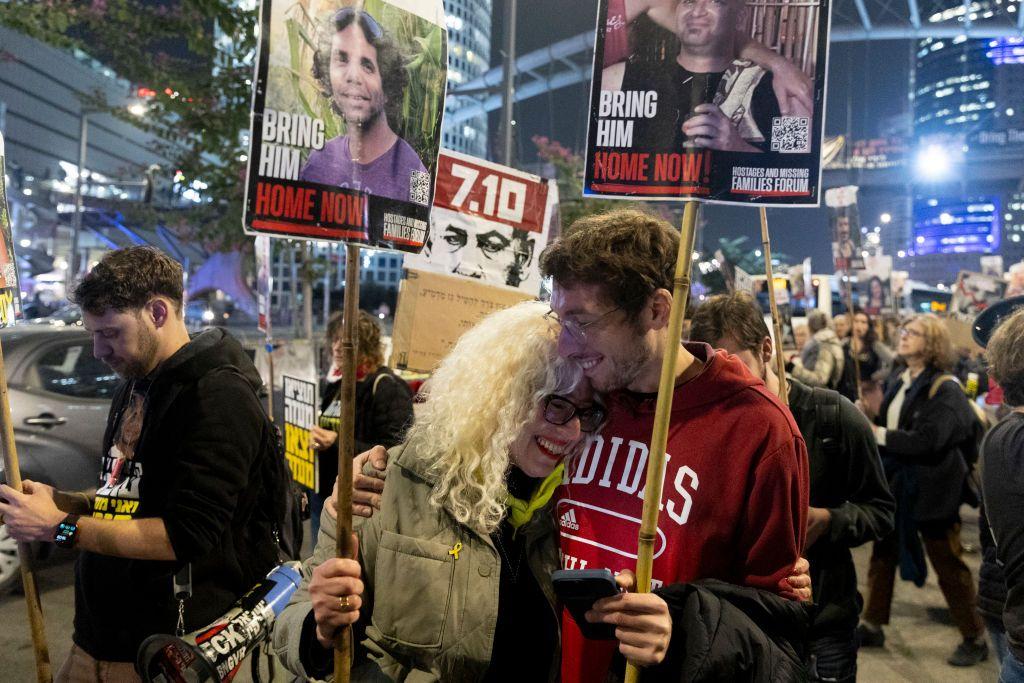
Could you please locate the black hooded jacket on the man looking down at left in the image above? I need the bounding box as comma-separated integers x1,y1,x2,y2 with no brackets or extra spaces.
74,329,276,661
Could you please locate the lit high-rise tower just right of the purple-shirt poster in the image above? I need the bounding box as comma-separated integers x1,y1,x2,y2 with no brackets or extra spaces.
441,0,492,159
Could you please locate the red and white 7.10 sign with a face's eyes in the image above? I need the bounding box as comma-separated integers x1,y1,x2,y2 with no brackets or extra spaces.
404,150,558,296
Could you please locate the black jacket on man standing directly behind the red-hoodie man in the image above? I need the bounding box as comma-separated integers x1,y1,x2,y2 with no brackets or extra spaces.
790,380,896,638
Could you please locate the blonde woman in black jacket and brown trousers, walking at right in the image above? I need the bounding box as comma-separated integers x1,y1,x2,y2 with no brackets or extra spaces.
858,313,988,667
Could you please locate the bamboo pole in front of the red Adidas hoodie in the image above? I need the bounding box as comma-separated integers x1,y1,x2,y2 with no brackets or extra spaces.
626,200,698,683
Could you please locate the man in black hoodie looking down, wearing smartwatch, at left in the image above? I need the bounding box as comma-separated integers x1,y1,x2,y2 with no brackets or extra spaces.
0,247,278,681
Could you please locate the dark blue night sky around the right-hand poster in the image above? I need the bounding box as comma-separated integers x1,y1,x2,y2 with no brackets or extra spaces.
490,0,910,272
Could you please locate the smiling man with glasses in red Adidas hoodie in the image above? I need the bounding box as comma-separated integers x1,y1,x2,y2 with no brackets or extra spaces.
541,211,809,683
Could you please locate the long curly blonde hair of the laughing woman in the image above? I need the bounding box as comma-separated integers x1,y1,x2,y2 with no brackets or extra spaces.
409,301,583,533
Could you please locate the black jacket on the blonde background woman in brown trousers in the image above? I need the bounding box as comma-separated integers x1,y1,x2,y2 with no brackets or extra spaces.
876,368,976,522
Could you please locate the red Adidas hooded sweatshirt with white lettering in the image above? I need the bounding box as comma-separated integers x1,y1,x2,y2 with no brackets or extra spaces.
554,344,809,683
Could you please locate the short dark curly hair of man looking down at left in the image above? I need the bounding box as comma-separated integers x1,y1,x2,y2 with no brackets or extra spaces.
72,247,183,315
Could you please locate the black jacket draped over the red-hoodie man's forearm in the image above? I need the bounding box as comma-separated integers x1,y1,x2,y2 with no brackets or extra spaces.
642,579,810,683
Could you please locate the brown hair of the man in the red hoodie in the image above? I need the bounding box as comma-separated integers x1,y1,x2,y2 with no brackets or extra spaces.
541,209,679,321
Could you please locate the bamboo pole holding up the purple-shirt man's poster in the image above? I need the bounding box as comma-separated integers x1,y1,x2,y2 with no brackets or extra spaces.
334,244,359,683
